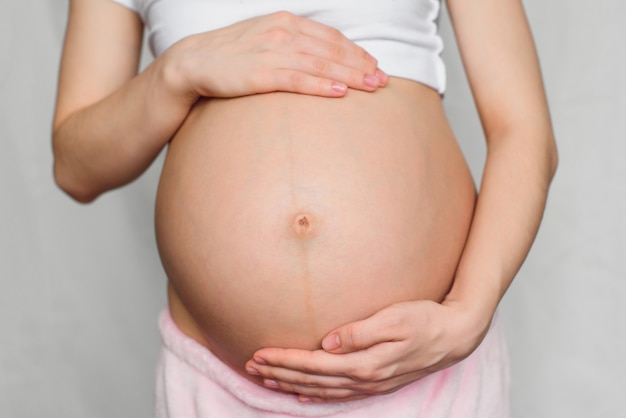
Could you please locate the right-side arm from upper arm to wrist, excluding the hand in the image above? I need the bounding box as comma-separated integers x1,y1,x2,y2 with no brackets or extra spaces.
444,0,557,329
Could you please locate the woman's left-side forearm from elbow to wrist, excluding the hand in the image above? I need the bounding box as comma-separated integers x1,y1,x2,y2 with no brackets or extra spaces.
53,61,195,202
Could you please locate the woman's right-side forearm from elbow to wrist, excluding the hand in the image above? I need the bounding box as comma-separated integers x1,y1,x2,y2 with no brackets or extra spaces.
446,129,557,325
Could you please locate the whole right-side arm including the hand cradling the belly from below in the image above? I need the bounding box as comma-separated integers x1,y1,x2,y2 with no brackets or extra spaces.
248,0,557,402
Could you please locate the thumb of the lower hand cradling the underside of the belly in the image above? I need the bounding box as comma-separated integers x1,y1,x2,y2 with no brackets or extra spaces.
322,312,392,354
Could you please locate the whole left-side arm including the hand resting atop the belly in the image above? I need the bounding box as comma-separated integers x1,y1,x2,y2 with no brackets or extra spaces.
53,0,386,202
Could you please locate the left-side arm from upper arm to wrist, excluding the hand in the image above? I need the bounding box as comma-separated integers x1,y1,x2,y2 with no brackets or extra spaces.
53,0,185,202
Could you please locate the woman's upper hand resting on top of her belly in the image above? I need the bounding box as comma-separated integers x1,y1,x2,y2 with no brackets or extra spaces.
162,12,387,97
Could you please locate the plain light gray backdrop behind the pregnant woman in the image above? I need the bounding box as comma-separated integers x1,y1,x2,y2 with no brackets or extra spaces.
0,0,626,418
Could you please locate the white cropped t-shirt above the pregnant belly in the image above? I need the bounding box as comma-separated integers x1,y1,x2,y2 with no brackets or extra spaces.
113,0,446,93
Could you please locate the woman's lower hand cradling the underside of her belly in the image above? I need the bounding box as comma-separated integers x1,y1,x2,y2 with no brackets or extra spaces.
246,301,491,402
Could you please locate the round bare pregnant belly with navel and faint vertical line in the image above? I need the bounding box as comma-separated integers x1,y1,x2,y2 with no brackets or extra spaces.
156,79,475,382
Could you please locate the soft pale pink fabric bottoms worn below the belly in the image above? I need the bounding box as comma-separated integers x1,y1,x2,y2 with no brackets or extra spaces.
156,311,510,418
